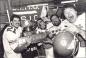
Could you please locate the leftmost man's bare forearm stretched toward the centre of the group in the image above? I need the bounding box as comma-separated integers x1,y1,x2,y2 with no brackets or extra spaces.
10,33,47,52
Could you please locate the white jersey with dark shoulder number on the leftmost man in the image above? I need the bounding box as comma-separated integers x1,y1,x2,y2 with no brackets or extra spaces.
3,26,22,58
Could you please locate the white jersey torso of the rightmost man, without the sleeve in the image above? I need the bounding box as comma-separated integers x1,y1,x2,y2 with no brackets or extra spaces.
74,13,86,58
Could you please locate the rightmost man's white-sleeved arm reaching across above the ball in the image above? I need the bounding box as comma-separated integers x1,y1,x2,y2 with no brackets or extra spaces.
62,22,86,40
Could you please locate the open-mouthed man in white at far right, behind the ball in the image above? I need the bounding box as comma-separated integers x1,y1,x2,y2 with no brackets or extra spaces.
61,4,86,58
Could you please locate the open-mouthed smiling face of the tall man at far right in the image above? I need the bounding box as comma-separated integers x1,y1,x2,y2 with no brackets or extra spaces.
64,7,77,23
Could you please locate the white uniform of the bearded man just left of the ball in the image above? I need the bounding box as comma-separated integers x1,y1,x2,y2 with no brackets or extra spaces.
45,22,58,58
